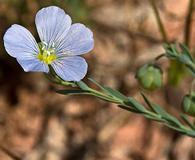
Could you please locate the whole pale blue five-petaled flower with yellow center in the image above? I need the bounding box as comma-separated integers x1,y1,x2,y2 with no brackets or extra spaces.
4,6,94,81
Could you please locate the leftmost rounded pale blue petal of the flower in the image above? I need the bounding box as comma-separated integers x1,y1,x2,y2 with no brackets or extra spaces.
3,24,38,59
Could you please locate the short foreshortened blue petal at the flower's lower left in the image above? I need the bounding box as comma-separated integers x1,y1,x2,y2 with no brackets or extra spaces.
17,58,49,73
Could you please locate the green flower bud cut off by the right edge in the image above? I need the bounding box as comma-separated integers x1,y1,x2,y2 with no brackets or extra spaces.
182,92,195,117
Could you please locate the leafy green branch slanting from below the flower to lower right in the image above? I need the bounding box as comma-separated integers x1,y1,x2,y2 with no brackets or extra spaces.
58,79,195,137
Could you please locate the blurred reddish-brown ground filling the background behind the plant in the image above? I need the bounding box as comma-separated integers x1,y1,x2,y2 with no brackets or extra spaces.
0,0,195,160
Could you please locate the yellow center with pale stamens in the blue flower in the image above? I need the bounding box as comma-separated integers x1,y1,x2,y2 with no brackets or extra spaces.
37,44,57,65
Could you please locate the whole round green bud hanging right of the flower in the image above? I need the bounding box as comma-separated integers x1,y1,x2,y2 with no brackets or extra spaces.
136,64,162,91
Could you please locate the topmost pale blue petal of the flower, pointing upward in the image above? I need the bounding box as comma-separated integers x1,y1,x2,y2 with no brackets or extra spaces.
35,6,72,48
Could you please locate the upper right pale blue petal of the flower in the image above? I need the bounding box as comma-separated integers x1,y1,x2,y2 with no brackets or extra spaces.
56,23,94,55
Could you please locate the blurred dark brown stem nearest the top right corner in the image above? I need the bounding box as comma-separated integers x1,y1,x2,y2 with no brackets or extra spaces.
184,0,194,47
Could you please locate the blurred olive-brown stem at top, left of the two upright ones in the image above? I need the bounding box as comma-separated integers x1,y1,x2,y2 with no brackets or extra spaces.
149,0,168,43
